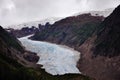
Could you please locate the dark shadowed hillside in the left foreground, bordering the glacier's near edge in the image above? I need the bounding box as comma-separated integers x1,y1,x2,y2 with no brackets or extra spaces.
0,26,94,80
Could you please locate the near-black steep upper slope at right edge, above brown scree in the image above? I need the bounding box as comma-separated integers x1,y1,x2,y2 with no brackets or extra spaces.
94,6,120,57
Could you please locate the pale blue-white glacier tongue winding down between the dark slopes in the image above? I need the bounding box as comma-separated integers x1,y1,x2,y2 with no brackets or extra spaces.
19,36,80,75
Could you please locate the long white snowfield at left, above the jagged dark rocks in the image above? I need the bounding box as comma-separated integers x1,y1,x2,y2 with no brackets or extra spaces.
7,17,62,29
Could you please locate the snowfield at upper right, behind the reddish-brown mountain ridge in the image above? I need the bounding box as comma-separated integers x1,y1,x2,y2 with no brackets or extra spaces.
74,8,114,17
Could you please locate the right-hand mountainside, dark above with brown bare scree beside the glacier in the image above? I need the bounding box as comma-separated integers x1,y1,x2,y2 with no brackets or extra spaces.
78,6,120,80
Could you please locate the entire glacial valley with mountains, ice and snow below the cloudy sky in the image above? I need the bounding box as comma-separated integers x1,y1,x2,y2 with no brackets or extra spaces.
0,2,120,80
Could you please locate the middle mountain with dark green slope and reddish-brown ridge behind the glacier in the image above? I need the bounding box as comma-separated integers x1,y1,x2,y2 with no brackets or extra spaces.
31,14,104,48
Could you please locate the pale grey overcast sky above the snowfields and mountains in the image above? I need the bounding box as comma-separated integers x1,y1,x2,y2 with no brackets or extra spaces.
0,0,120,26
